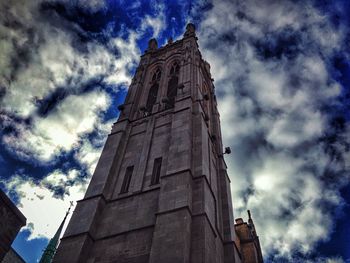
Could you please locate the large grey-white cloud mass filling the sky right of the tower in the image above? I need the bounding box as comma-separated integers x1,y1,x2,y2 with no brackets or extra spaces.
199,0,350,262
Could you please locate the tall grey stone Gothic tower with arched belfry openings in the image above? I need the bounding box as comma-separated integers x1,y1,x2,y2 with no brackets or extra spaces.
54,24,240,263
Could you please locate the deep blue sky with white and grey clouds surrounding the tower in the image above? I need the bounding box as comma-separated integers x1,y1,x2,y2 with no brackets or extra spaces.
0,0,350,263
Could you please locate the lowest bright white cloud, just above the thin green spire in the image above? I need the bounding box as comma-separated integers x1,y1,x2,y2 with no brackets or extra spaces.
6,170,86,239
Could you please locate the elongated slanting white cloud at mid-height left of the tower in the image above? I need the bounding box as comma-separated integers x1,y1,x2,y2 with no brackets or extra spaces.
3,91,110,162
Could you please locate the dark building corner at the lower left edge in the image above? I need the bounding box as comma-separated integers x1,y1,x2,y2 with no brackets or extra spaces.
0,189,26,262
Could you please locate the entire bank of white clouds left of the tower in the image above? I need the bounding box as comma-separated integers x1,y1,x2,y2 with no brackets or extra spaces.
0,0,165,245
